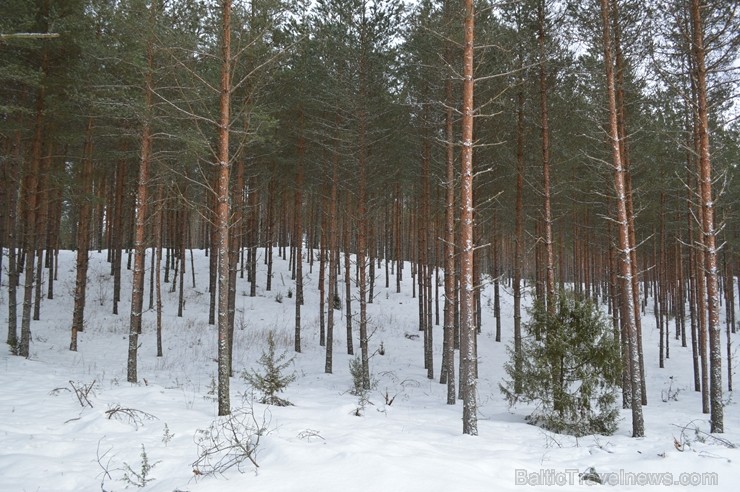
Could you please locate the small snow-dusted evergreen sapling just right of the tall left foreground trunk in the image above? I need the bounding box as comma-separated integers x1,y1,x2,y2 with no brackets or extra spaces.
242,331,296,407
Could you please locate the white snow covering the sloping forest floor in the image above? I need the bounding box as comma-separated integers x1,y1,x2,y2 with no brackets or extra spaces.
0,251,740,492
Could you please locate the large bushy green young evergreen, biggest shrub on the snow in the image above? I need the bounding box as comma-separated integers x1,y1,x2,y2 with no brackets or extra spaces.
500,292,621,436
